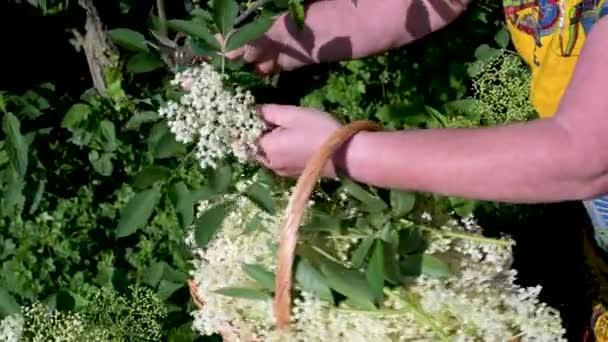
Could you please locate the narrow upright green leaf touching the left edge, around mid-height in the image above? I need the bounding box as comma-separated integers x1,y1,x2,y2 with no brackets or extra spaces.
2,113,28,177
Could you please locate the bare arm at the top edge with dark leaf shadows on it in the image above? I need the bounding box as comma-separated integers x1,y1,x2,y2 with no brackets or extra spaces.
268,0,469,68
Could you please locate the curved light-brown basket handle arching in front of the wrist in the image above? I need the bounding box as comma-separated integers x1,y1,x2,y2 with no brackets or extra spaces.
274,120,382,329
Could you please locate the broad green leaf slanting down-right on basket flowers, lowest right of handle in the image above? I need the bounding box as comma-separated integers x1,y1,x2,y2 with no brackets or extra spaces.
318,257,376,309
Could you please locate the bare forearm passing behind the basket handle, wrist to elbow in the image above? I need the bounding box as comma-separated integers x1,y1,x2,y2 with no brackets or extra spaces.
344,119,601,203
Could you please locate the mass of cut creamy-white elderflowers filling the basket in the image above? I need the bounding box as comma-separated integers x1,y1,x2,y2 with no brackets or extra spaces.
193,195,565,342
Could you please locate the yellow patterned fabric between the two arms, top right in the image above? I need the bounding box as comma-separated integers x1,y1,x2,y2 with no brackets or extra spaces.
503,0,608,117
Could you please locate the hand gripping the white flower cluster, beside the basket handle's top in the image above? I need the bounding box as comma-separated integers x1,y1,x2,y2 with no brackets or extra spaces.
257,104,342,177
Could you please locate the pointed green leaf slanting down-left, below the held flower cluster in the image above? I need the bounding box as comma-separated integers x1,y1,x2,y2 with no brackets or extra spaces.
116,188,161,238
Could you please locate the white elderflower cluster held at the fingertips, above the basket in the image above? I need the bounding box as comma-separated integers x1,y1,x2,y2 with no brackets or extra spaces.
159,63,265,168
